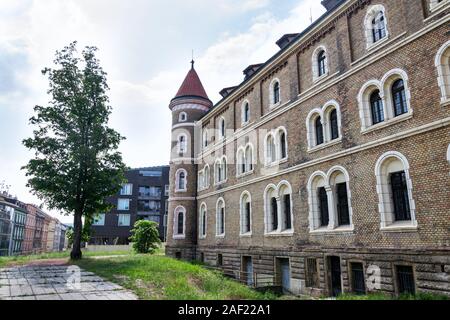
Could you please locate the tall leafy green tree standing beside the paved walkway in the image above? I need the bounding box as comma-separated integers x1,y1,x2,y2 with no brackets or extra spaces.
22,42,125,259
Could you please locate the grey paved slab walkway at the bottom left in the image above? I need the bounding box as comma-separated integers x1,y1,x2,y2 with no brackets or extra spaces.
0,265,137,300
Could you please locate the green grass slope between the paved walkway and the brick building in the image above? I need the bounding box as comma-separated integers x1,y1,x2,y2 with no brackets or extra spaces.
77,255,276,300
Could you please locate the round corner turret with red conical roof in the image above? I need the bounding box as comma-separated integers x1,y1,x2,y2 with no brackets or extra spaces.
166,61,213,260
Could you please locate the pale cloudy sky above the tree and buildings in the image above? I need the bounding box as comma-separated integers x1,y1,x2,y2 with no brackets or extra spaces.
0,0,324,222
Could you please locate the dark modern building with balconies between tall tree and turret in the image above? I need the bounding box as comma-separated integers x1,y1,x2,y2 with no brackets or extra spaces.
90,166,169,245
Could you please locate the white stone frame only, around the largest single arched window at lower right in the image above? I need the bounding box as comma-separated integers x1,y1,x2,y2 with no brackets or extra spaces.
375,151,418,231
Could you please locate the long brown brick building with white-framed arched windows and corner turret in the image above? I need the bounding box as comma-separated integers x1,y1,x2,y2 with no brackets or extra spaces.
166,0,450,295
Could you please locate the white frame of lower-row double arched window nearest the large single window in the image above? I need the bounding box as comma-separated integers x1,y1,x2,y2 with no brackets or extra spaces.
307,166,355,233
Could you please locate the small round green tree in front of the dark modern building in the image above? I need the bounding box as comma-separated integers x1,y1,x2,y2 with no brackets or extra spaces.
130,220,161,253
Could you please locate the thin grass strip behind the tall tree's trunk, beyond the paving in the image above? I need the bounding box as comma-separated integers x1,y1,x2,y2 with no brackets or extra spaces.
0,251,131,268
